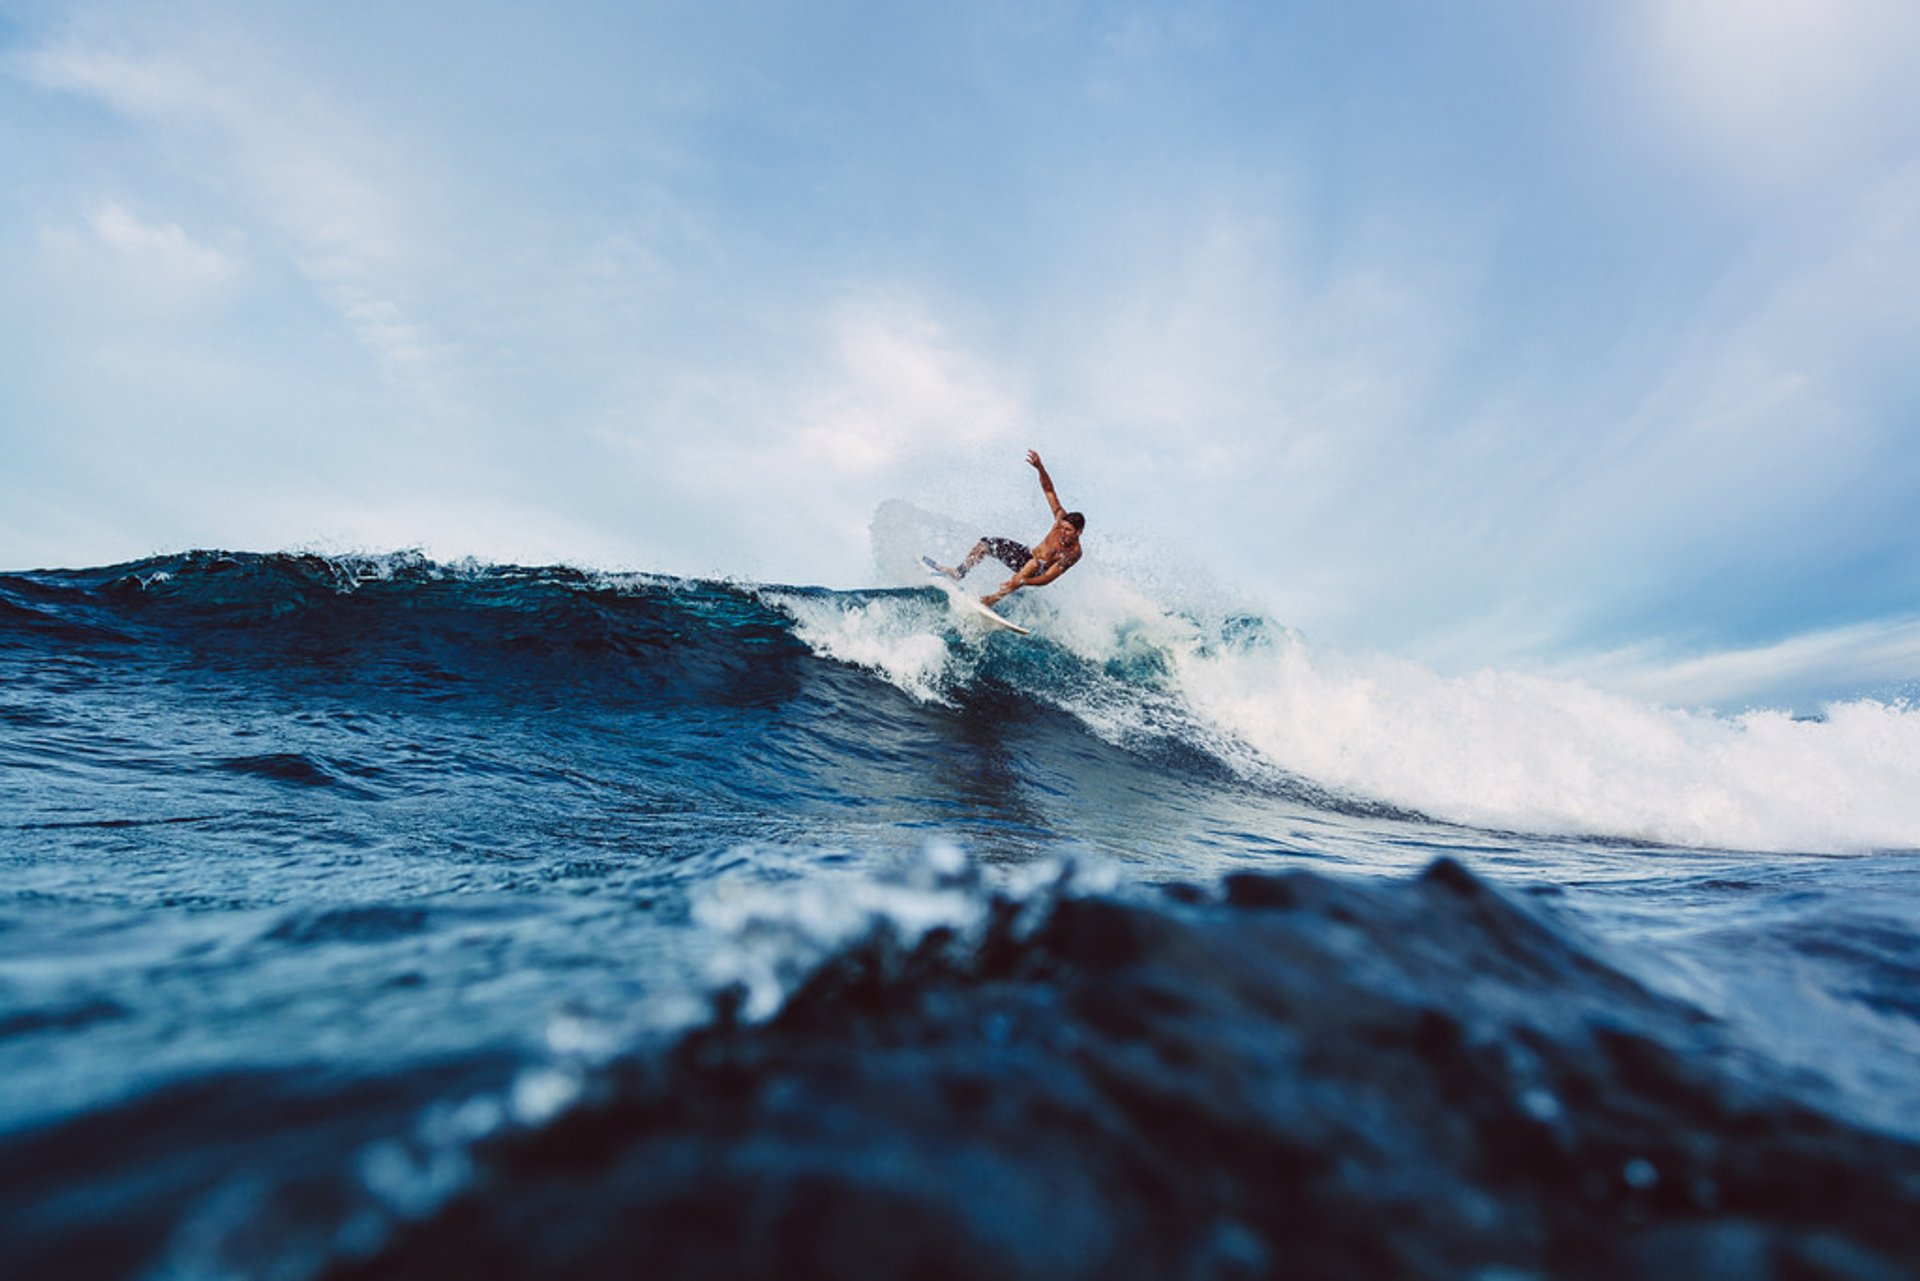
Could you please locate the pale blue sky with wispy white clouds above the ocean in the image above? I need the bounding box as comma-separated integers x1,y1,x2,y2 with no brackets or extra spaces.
0,0,1920,701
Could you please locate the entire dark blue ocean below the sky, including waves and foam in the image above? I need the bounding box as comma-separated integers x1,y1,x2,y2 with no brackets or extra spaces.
0,549,1920,1279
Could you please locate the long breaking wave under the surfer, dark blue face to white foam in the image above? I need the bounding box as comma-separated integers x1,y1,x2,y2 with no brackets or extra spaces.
0,551,1920,853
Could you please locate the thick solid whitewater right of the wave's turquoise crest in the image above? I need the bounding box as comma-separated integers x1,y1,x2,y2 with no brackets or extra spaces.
1177,638,1920,853
